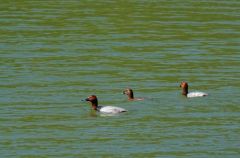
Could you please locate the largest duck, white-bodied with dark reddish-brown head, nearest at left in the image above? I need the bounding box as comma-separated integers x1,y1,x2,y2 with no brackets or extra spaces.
85,95,127,114
